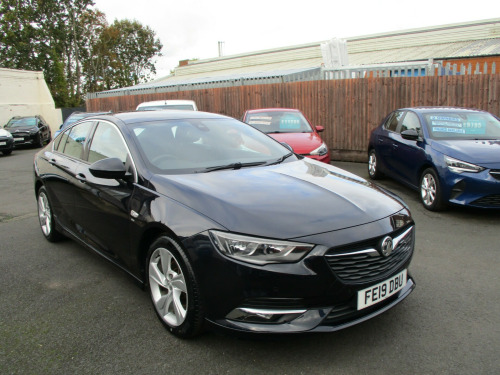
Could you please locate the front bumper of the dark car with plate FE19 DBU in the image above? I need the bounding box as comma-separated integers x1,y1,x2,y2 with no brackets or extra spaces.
184,218,415,333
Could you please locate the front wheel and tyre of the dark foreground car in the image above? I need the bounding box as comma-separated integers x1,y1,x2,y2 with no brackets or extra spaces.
147,236,204,338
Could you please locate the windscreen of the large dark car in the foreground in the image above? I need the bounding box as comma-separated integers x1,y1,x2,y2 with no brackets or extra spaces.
133,119,296,174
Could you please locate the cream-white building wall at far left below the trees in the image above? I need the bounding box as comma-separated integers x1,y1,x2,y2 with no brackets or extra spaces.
0,68,62,134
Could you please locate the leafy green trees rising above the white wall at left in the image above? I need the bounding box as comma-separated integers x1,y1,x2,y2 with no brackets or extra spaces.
0,0,162,107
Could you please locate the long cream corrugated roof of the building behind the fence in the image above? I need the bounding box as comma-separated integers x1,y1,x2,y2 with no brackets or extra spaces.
92,18,500,96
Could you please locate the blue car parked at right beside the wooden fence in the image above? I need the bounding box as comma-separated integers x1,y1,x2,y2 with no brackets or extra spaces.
368,107,500,211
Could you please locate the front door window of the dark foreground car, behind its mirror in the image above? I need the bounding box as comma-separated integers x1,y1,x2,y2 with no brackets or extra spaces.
89,122,128,163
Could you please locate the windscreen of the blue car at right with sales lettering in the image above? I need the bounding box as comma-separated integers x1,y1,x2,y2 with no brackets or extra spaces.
424,112,500,140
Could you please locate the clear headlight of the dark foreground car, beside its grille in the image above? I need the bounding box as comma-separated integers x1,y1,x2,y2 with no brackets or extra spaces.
210,230,314,264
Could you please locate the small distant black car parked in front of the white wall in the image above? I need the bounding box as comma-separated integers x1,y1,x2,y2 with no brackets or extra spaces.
4,115,52,147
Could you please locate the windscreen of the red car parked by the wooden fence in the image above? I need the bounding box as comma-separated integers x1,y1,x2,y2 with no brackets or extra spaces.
245,111,312,133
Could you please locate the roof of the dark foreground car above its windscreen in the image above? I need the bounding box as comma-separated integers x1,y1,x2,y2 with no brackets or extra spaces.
97,109,232,124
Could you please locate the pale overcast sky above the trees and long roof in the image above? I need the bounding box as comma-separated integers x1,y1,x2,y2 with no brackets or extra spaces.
94,0,500,76
